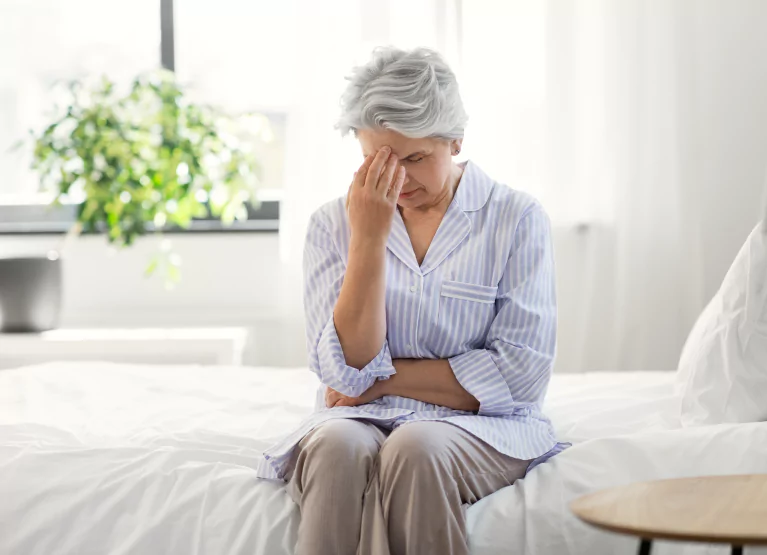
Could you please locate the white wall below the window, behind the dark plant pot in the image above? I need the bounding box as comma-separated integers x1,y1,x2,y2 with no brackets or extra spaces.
0,232,305,366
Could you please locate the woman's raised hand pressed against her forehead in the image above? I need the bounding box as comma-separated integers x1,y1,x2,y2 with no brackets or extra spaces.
346,147,405,244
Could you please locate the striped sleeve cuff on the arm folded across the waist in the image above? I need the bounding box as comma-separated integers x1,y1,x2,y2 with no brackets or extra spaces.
448,349,516,416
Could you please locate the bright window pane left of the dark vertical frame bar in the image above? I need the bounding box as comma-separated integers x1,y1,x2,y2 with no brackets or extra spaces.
0,0,160,199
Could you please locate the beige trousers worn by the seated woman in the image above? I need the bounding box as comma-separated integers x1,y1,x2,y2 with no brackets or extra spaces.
287,418,530,555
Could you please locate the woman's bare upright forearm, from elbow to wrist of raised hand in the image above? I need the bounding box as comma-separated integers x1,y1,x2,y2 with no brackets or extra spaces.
333,237,386,369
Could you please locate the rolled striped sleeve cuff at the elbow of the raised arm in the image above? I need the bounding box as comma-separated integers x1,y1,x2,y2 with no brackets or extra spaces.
317,315,395,397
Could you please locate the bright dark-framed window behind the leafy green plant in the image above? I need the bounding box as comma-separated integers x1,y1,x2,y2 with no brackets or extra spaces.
0,0,287,233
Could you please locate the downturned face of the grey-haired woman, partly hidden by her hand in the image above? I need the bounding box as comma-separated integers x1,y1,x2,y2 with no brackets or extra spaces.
357,129,461,209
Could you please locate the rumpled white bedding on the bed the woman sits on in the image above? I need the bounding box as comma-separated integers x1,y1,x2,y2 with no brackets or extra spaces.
0,362,767,555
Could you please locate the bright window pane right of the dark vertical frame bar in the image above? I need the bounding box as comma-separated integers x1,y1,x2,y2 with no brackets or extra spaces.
174,0,296,198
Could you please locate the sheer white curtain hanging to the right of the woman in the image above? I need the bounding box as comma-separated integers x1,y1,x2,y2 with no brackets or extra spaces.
462,0,767,371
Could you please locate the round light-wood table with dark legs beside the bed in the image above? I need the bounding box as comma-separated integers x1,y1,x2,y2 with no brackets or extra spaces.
570,474,767,555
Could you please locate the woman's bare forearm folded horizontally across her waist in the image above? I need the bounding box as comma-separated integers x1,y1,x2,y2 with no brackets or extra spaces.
378,359,479,411
